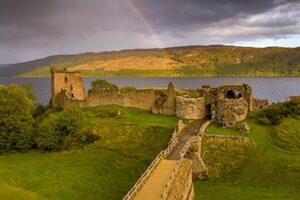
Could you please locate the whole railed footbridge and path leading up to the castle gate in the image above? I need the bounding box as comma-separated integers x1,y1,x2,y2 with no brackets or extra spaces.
123,120,211,200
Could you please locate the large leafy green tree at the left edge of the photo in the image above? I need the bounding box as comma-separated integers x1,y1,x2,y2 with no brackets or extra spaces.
0,85,33,152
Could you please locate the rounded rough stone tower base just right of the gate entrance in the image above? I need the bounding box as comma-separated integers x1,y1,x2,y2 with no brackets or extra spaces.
216,98,248,128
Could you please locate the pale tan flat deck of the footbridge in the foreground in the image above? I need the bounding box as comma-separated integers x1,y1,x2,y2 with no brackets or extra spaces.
134,160,177,200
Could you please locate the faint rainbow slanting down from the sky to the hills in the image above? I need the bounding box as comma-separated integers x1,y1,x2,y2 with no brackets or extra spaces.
126,0,170,58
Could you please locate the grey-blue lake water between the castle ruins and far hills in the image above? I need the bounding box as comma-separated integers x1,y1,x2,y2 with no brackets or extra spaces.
0,77,300,104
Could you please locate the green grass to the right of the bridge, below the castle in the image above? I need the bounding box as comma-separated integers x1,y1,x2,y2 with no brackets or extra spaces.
194,118,300,200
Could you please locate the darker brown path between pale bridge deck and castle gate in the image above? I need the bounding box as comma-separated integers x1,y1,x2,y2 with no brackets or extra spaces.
167,119,205,160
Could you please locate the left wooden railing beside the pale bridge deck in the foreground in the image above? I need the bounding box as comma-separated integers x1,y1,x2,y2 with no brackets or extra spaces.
123,151,164,200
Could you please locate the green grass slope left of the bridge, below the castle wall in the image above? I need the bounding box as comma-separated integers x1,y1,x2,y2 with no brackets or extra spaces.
0,106,177,200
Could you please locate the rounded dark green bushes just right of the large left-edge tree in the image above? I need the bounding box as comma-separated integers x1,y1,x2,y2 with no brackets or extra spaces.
35,109,100,151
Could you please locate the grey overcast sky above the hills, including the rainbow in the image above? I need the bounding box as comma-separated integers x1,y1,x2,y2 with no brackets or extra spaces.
0,0,300,63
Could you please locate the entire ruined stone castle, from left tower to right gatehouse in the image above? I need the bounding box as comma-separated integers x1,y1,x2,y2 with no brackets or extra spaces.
50,66,269,127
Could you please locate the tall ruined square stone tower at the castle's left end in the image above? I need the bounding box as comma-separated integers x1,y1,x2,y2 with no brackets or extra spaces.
50,65,86,107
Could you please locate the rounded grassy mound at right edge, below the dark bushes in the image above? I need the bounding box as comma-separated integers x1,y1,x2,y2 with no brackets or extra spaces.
272,118,300,152
